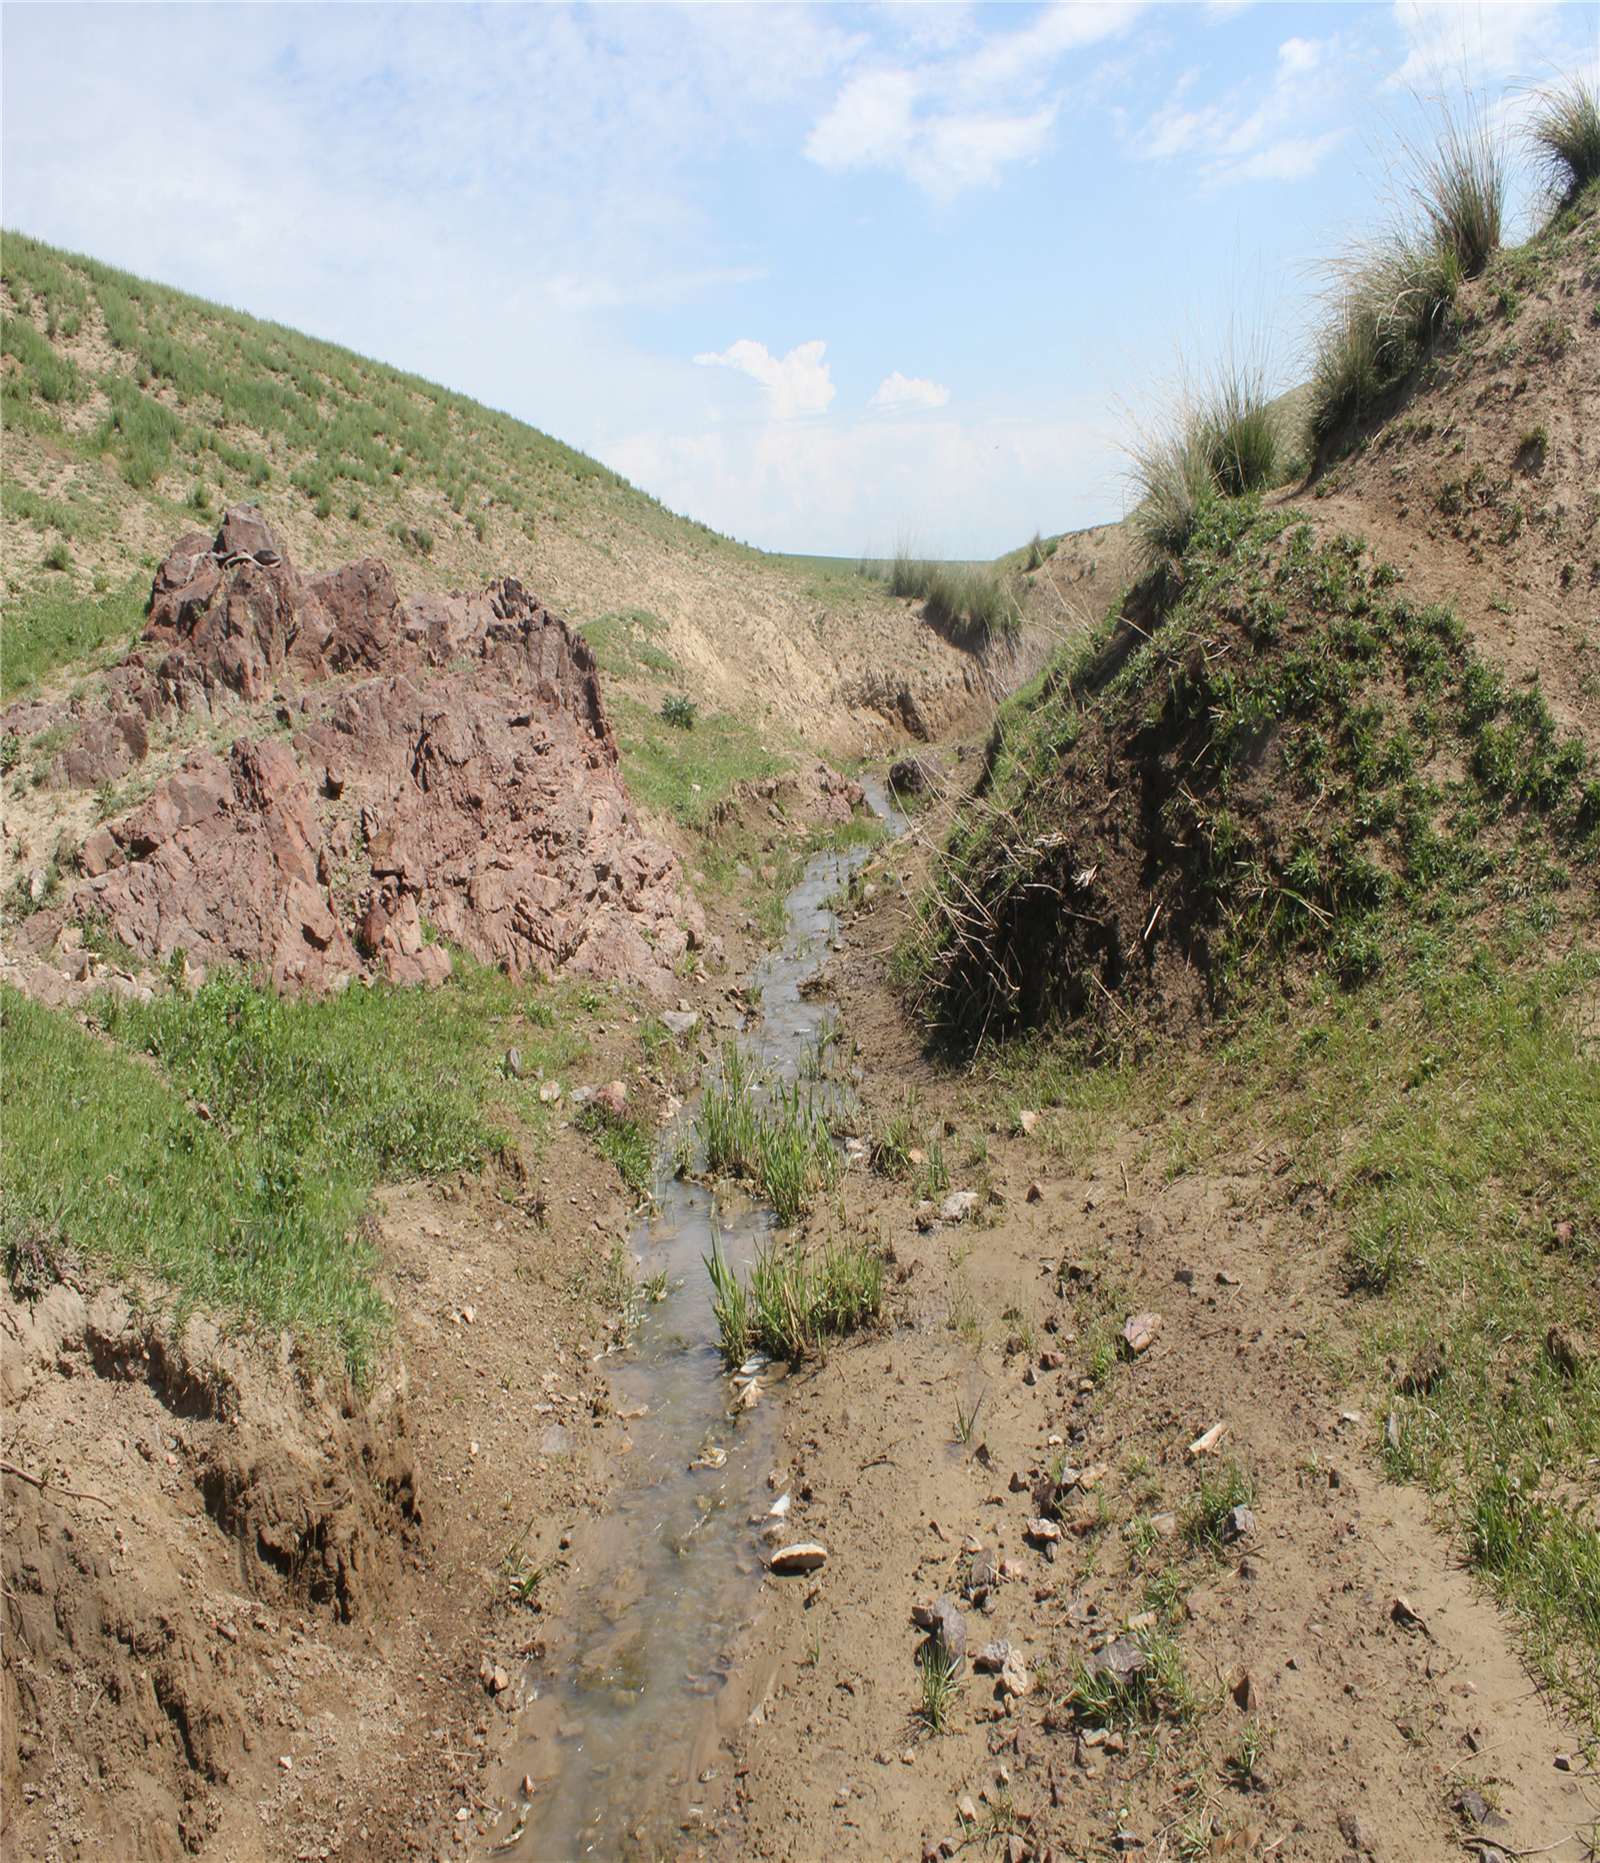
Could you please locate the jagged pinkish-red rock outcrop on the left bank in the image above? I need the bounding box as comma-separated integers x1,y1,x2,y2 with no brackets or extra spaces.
17,507,704,993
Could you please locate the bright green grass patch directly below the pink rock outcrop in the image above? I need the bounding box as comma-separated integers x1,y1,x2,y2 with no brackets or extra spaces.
0,963,588,1377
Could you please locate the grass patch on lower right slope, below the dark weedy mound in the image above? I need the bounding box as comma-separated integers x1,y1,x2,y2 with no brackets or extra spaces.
1207,946,1600,1720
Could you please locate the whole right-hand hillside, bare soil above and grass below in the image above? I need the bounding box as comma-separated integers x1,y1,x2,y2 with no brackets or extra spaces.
898,163,1600,1720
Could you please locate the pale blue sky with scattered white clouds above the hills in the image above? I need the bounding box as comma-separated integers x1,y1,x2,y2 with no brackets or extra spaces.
0,0,1600,555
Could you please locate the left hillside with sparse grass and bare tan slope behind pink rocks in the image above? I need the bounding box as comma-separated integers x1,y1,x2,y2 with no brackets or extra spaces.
0,233,967,751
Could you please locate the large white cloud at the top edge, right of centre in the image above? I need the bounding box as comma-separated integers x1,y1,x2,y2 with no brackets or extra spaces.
805,0,1138,199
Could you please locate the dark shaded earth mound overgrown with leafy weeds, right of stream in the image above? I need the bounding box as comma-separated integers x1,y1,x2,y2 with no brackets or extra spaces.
905,499,1600,1038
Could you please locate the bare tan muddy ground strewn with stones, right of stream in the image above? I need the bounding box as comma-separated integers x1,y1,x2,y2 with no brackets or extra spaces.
684,818,1600,1863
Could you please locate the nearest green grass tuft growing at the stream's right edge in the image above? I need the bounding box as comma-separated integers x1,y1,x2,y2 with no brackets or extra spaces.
706,1241,883,1366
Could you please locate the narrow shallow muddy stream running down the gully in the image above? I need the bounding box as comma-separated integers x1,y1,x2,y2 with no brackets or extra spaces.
490,779,905,1863
